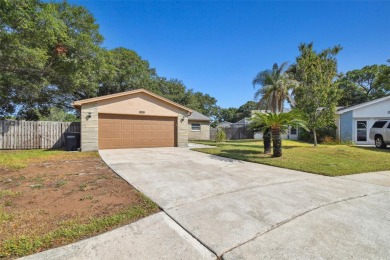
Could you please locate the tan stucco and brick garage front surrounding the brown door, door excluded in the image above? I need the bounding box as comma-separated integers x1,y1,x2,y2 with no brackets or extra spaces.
73,89,192,151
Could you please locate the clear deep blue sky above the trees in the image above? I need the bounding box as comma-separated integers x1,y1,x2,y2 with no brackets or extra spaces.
68,0,390,108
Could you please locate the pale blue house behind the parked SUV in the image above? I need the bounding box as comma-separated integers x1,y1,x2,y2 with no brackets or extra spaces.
336,96,390,144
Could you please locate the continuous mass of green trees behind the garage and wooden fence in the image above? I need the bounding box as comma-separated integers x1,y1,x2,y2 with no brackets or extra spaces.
0,0,218,120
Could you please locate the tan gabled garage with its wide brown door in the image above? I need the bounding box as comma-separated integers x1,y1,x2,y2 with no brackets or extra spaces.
73,89,192,151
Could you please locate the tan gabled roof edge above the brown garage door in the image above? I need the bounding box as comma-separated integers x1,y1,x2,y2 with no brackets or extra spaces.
73,88,192,113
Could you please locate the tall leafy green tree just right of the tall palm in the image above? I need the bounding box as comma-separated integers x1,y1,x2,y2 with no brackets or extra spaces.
295,43,341,145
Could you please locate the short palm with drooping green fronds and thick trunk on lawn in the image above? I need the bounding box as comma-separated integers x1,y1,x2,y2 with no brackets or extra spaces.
251,111,308,157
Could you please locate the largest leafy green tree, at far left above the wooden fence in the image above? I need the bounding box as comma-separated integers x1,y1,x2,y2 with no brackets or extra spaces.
0,0,103,119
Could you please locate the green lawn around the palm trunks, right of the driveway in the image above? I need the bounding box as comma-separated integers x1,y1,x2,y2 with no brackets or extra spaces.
193,140,390,176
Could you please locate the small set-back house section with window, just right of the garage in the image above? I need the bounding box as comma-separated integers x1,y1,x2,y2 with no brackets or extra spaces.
188,111,211,140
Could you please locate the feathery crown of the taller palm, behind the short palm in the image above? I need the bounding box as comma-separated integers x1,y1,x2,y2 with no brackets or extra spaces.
252,62,298,113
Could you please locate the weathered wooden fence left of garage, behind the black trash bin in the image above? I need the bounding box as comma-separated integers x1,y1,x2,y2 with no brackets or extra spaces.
0,120,80,149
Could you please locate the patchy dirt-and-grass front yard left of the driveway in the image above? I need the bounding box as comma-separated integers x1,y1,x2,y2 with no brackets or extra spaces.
0,150,159,258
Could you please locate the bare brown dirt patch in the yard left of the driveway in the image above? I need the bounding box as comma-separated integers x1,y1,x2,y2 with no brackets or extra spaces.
0,152,158,257
